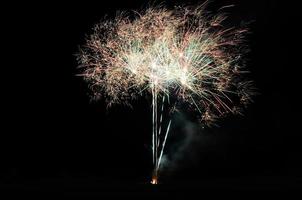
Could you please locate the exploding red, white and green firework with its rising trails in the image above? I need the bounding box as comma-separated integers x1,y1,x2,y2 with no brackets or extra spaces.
77,4,252,184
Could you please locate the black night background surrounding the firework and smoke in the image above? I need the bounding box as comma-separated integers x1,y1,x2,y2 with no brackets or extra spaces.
0,0,301,196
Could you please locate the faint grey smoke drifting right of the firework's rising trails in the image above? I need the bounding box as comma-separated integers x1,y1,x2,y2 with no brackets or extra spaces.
160,113,228,176
